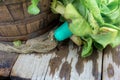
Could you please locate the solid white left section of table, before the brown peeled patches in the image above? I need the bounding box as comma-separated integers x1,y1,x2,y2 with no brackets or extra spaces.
11,53,54,80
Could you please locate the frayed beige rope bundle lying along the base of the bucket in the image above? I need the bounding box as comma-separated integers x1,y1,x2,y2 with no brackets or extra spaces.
0,31,58,54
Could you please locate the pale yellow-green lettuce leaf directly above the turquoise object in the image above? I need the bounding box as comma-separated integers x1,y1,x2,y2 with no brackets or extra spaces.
64,4,92,36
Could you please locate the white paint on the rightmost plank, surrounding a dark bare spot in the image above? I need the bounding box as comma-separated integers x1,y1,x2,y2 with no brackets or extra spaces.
103,52,120,80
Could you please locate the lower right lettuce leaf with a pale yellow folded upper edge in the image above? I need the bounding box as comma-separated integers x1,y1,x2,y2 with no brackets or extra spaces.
91,27,118,48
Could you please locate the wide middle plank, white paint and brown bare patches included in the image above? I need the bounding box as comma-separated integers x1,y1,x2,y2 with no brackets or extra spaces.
11,42,102,80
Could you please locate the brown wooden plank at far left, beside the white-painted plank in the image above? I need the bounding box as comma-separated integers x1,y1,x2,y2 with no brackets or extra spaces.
0,51,18,77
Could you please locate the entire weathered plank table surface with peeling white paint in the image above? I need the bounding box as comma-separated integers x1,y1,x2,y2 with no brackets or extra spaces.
0,42,120,80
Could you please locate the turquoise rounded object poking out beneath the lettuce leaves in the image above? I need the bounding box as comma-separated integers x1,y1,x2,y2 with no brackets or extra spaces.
54,22,72,41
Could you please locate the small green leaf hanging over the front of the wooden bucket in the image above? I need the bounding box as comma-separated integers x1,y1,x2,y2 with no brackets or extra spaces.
28,0,40,15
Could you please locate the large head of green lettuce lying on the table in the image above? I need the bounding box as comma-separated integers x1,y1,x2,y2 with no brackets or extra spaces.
51,0,120,57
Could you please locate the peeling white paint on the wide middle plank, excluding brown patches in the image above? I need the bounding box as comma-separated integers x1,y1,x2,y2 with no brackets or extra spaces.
11,43,102,80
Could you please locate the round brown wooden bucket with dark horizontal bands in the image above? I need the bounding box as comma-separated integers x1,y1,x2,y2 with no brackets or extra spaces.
0,0,58,41
